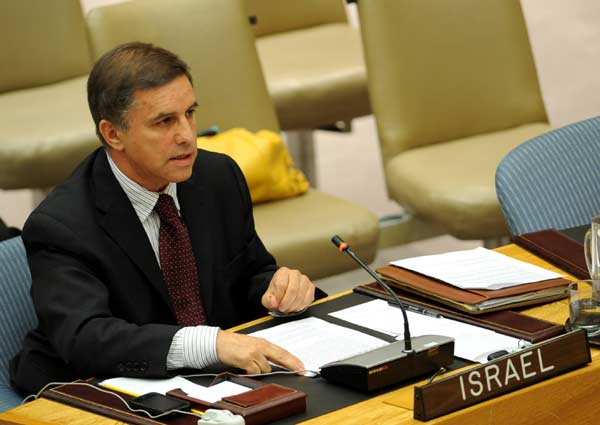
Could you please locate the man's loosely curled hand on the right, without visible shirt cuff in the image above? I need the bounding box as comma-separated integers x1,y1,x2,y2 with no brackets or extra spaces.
262,267,315,313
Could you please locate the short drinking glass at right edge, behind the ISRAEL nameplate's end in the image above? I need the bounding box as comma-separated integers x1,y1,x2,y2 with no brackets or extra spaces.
569,280,600,337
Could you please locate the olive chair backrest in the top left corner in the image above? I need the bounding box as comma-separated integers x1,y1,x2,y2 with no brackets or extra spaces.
0,0,91,93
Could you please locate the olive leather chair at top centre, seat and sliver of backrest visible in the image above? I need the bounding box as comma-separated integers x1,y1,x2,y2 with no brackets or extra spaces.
245,0,371,130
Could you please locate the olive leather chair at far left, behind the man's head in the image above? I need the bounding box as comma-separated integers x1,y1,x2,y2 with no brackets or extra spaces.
0,0,99,189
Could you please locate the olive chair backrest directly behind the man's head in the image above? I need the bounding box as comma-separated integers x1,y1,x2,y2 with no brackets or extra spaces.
87,0,279,131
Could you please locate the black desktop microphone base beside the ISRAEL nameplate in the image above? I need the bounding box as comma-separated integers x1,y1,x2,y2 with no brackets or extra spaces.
321,335,454,392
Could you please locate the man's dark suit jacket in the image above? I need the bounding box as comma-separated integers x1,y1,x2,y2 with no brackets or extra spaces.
11,148,277,392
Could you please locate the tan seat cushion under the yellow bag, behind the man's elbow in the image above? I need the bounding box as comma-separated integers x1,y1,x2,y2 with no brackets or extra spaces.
254,189,379,279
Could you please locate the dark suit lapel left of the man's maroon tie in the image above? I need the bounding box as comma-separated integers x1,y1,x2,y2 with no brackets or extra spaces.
93,152,173,311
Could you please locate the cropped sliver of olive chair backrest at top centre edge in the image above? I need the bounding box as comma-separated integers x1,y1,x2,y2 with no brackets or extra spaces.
245,0,348,37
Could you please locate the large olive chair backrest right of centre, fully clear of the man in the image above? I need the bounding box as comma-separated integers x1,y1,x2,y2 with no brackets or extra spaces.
358,0,546,161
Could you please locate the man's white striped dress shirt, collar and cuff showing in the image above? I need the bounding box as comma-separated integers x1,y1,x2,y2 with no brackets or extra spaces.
106,152,219,370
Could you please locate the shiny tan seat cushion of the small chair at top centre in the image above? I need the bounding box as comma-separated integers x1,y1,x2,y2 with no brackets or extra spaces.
256,23,371,130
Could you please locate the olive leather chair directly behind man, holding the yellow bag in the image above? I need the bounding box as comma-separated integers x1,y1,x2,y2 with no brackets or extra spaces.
87,0,379,279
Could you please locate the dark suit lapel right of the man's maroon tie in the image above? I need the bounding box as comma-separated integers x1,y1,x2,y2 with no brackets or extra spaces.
177,170,215,318
